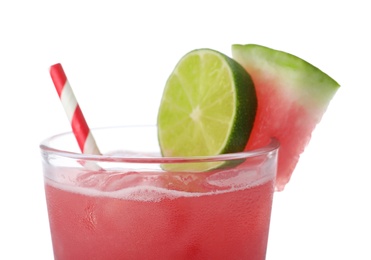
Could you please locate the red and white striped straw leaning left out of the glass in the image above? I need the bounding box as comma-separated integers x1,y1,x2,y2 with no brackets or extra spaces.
50,63,100,154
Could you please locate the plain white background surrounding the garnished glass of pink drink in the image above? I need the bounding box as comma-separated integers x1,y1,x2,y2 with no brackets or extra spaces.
0,0,371,260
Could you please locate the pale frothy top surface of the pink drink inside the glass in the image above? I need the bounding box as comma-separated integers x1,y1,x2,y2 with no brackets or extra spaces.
46,153,273,202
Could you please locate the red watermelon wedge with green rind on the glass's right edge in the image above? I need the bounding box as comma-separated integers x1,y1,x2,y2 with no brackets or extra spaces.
232,44,339,191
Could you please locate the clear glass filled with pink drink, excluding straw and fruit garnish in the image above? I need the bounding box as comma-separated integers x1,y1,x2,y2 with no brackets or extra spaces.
41,127,278,260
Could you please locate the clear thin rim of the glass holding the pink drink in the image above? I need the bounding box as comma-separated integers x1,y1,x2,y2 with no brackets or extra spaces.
39,125,280,163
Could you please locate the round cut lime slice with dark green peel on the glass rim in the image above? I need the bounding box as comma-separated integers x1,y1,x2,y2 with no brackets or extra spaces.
157,49,257,171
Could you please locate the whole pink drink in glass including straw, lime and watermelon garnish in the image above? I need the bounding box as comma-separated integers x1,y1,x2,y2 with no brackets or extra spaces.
41,45,339,260
